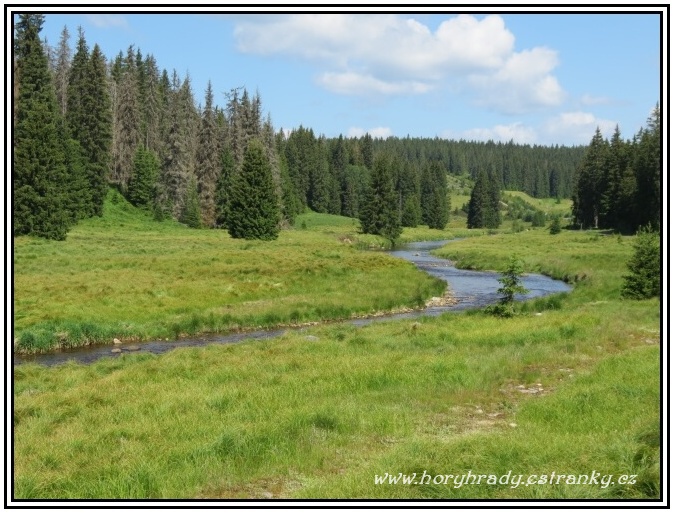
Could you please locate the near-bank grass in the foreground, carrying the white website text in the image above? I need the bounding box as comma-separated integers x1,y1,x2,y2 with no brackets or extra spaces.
13,219,661,499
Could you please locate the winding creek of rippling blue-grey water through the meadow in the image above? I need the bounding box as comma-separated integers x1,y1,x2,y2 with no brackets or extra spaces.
13,240,571,366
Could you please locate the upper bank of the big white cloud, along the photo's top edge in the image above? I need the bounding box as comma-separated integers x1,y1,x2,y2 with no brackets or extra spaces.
234,14,514,80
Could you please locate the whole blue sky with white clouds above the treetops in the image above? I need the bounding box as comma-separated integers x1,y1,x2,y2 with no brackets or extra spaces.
31,7,667,145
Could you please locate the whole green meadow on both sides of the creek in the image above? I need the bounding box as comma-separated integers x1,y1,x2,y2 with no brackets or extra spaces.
13,191,661,499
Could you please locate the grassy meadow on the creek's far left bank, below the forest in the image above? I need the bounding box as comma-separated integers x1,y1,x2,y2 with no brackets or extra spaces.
14,192,445,352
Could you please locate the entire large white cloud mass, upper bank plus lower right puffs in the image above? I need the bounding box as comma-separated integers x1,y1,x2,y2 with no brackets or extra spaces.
234,14,565,114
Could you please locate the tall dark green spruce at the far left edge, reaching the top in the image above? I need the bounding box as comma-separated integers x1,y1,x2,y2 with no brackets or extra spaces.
12,14,77,240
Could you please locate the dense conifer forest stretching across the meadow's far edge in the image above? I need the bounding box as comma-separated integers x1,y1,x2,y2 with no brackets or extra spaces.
13,14,660,239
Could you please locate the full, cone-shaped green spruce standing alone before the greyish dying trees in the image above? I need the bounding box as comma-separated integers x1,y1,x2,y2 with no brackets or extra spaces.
226,139,280,240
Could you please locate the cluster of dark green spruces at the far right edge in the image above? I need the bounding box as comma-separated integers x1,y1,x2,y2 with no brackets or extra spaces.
572,110,662,233
